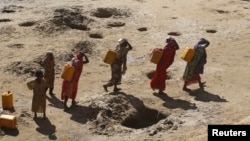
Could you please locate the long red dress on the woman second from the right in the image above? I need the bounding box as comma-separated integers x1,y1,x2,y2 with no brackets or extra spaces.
150,41,177,91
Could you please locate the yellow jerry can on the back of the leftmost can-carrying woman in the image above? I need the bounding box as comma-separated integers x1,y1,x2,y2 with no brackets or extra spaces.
61,63,75,81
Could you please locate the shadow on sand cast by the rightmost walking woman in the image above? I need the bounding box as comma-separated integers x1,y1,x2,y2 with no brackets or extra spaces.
189,88,228,102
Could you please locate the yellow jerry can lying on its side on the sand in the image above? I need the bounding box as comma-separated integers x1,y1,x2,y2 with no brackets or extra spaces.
0,114,17,128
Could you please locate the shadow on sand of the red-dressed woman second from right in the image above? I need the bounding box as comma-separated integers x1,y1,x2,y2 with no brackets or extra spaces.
153,93,197,110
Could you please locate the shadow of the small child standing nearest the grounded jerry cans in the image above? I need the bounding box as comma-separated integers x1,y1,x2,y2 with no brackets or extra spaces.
35,118,57,140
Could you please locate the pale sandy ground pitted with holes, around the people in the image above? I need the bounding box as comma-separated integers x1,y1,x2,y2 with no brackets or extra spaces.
0,0,250,141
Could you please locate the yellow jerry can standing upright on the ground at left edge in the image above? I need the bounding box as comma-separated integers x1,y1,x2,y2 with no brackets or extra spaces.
2,91,13,109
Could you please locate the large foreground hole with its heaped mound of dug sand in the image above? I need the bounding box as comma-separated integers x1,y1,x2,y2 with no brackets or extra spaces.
88,92,167,135
